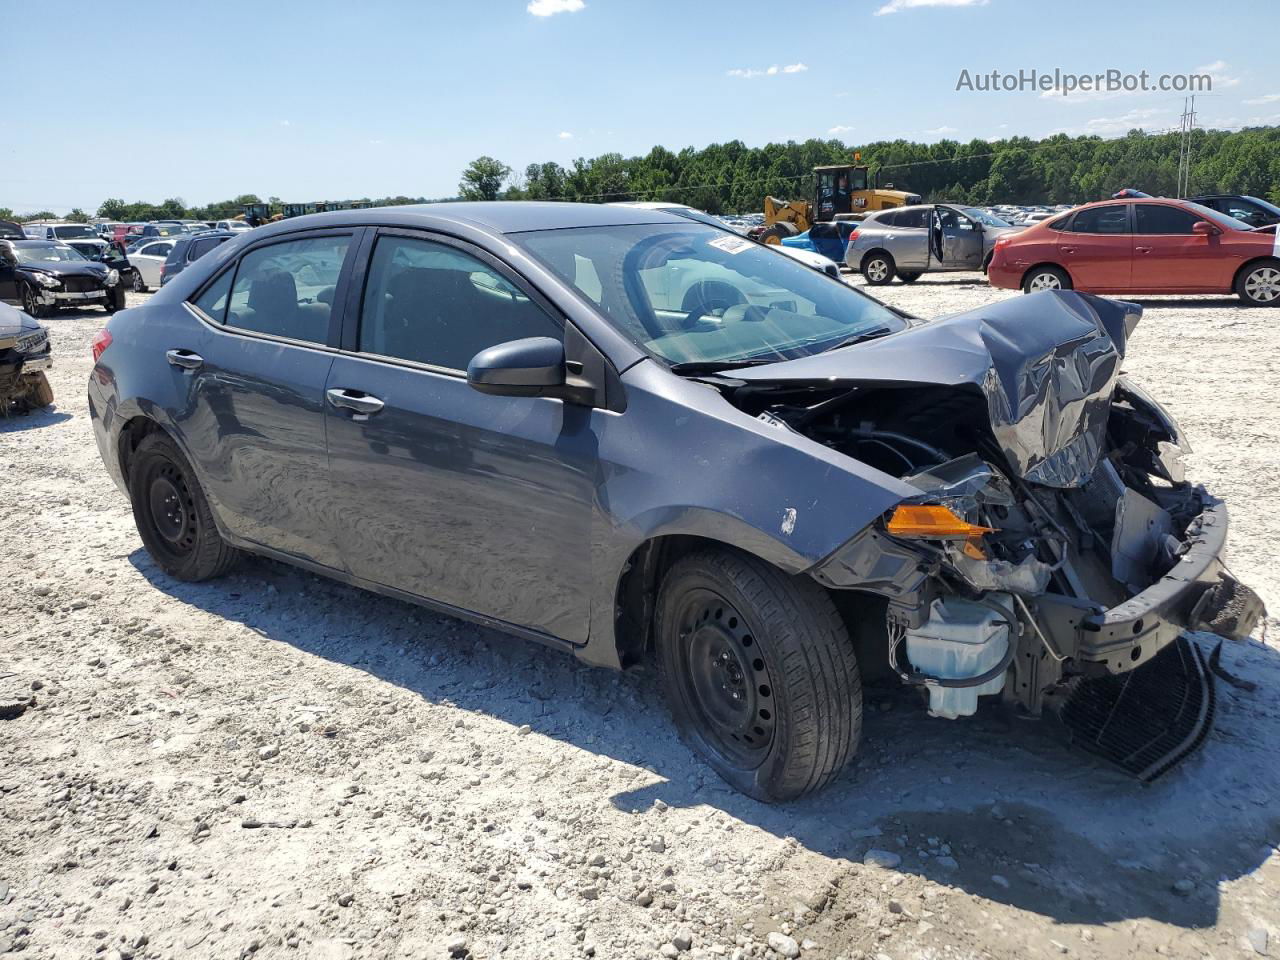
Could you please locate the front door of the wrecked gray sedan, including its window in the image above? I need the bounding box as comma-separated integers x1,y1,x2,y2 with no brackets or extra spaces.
326,232,596,643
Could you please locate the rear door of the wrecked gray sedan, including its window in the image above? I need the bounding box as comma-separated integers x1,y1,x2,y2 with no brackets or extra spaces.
172,230,355,570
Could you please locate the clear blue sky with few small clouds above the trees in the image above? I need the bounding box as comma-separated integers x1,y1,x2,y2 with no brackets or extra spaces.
0,0,1280,212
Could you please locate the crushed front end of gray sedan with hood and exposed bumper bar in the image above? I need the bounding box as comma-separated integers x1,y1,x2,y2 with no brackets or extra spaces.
737,293,1263,778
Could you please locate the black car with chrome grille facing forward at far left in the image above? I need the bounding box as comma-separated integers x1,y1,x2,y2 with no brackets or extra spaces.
0,239,123,317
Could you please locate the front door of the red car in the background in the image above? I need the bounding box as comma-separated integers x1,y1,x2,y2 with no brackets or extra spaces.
1133,202,1239,293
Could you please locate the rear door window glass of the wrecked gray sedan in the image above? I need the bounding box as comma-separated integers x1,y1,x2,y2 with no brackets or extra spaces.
227,237,351,343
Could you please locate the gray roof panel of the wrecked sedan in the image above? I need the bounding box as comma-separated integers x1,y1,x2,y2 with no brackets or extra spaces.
248,200,689,236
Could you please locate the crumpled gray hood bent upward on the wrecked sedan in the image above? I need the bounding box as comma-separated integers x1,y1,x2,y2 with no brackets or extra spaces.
731,291,1142,488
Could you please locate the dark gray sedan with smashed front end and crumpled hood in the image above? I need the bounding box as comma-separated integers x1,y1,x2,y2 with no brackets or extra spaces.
88,204,1261,801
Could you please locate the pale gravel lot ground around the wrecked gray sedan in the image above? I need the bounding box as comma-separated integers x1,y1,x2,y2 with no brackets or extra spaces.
0,275,1280,960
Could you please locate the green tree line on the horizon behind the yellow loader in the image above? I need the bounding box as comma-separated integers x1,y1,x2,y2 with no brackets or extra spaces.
458,127,1280,214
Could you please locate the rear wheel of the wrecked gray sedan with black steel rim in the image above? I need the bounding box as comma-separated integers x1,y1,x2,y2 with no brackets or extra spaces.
129,433,241,581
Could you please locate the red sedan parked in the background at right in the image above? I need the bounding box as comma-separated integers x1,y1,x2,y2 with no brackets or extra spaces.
987,197,1280,307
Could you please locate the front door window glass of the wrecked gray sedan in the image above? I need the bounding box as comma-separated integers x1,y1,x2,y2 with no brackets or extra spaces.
360,237,562,370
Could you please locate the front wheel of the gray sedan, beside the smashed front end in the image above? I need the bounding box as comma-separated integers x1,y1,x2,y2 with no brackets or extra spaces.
657,550,863,803
